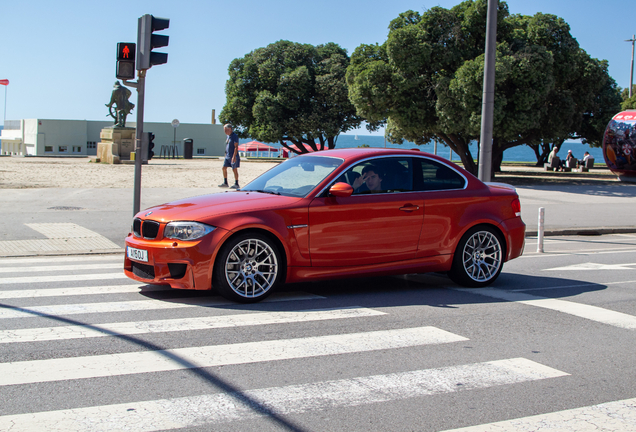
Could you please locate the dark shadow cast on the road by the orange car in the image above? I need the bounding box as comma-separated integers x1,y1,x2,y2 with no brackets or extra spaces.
140,272,607,311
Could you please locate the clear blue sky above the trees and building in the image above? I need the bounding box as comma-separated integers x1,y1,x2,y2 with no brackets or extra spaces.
0,0,636,133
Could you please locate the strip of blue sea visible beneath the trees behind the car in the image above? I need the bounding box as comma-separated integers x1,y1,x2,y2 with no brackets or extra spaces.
240,135,604,163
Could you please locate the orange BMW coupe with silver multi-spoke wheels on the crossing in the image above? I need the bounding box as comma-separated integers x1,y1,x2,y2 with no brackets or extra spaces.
124,149,525,303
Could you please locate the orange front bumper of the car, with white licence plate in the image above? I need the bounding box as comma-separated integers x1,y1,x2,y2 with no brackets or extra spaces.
124,228,229,290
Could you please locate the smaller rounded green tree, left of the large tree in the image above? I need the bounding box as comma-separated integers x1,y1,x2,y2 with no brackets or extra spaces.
219,41,361,153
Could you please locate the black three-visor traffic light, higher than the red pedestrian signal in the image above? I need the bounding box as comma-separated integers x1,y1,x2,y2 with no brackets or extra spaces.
137,14,170,70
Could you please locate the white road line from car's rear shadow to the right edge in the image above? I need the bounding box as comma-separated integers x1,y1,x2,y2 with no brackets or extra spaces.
458,288,636,329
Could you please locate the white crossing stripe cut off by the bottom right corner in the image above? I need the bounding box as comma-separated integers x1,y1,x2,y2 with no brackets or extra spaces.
446,399,636,432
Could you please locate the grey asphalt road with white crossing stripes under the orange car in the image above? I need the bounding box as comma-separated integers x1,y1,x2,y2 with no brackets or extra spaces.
0,234,636,432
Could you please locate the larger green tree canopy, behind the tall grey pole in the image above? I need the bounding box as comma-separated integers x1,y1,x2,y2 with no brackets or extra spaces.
347,0,621,173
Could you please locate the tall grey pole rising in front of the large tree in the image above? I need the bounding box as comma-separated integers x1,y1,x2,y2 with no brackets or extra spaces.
478,0,499,182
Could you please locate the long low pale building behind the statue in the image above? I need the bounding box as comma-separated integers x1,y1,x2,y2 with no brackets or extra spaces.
0,119,227,157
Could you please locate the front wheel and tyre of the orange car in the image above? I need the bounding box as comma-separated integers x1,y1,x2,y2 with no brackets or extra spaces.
212,233,283,303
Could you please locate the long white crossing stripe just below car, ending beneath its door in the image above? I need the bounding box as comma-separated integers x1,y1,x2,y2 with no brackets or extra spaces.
0,306,386,343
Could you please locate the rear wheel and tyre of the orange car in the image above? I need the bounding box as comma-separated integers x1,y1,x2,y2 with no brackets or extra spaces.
448,225,505,288
